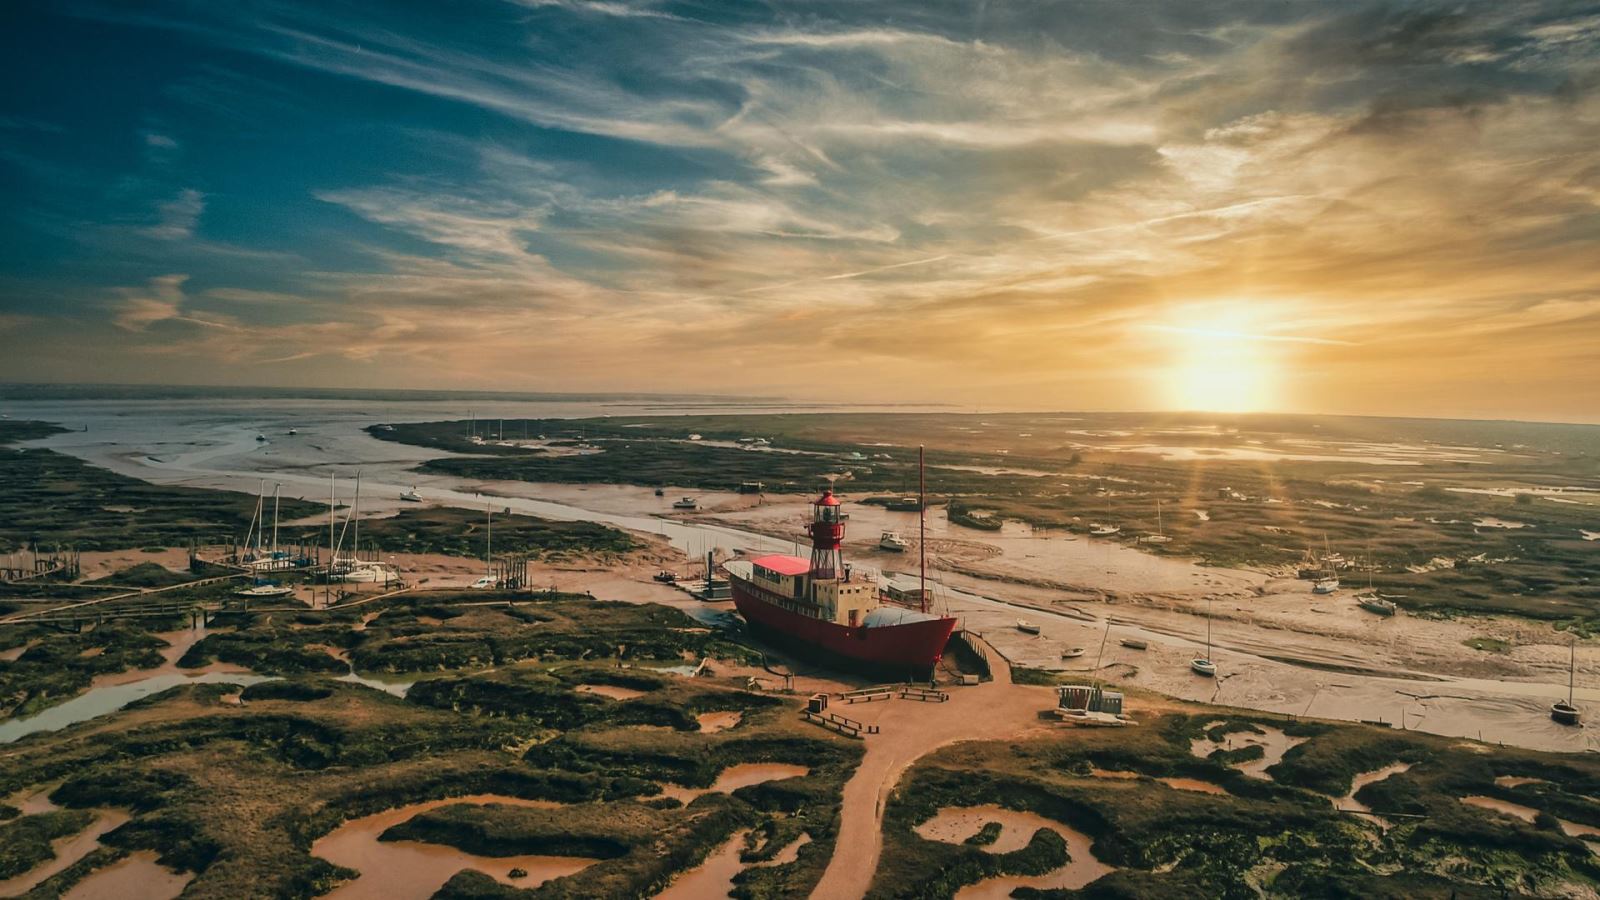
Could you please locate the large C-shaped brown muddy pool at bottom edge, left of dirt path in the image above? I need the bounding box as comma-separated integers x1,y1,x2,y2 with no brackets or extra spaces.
310,794,600,900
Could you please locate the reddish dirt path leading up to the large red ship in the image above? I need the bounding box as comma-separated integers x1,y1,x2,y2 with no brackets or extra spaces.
811,653,1056,900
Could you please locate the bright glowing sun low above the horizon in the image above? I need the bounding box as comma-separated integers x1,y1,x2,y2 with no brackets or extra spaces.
1157,307,1282,413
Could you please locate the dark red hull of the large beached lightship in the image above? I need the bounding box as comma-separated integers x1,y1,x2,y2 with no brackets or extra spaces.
731,578,955,677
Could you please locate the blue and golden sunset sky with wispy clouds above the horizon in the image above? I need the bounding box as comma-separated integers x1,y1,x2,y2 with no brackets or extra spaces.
0,0,1600,421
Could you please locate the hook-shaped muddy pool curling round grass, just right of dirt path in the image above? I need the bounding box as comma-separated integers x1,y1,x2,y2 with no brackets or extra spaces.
917,804,1112,900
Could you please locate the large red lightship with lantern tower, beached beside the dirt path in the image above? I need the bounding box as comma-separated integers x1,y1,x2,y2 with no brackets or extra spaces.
725,490,955,677
